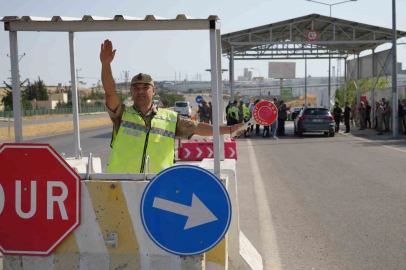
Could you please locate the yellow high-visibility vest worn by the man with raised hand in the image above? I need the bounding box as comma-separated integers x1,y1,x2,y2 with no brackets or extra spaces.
107,106,178,173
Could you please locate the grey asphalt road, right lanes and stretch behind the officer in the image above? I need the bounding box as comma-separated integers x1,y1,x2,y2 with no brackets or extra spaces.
3,122,406,270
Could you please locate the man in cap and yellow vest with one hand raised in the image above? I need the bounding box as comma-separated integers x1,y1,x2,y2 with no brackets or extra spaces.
100,40,243,173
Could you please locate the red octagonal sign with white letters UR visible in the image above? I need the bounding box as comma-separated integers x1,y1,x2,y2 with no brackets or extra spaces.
0,143,80,256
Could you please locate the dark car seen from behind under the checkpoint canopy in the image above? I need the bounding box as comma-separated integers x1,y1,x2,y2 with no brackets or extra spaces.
294,107,335,137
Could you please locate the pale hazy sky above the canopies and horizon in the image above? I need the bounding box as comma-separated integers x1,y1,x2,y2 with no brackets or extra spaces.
0,0,406,86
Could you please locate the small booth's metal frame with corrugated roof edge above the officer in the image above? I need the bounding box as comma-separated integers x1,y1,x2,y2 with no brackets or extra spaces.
0,14,224,175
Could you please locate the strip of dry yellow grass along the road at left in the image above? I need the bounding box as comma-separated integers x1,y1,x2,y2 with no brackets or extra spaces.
0,118,112,141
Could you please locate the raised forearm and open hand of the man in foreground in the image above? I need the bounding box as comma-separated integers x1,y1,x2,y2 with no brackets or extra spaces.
100,40,120,112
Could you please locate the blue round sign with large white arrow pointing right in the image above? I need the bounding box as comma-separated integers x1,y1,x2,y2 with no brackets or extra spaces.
140,165,231,256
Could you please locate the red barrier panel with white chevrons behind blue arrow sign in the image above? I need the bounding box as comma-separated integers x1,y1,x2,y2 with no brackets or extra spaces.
178,141,237,161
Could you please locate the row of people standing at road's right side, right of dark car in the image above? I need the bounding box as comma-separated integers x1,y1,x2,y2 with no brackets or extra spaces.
333,98,406,135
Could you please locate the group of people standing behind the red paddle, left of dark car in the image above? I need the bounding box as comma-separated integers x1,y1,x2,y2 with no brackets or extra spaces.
226,98,290,140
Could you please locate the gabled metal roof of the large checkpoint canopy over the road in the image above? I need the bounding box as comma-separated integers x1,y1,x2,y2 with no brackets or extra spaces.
221,14,406,60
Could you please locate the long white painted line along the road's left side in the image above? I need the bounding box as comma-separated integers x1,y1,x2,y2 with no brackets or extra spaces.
247,140,282,270
